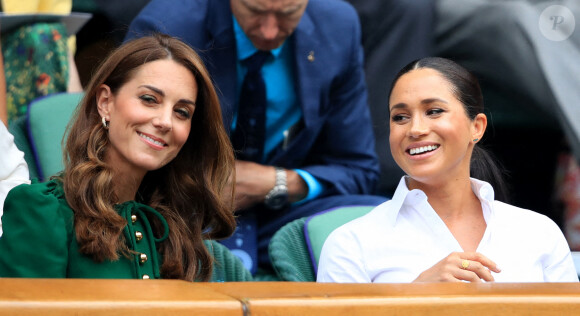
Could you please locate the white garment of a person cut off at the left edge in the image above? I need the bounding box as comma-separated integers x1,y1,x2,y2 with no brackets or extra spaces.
0,122,30,235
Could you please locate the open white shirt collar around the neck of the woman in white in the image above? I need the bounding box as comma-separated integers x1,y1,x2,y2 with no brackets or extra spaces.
387,176,495,226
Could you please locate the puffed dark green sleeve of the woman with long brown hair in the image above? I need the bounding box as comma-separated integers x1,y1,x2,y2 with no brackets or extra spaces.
0,183,72,278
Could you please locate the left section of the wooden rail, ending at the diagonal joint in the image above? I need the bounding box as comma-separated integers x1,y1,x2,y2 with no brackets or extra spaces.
0,279,243,316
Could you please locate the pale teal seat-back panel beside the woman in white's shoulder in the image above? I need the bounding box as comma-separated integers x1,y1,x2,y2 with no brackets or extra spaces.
304,206,375,271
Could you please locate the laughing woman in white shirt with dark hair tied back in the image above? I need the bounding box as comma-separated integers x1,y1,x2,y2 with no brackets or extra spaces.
318,57,578,282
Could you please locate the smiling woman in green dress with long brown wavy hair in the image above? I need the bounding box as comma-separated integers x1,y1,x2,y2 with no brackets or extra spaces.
0,35,235,281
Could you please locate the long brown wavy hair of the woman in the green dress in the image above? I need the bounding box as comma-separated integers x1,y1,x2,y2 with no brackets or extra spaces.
61,34,235,281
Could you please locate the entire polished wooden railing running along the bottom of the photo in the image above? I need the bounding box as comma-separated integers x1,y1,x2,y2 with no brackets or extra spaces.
0,279,580,316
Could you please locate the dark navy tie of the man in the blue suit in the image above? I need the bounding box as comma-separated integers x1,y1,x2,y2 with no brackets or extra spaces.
232,51,272,162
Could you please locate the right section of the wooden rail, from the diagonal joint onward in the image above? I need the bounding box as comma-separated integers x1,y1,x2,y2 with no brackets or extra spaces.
207,283,580,316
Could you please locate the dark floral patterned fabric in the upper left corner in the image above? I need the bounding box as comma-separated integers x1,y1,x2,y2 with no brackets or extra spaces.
2,23,69,122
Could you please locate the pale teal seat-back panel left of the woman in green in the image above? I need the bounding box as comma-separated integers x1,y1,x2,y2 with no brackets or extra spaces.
27,93,83,181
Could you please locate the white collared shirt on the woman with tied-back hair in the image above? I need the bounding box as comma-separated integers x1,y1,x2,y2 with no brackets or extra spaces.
317,177,578,283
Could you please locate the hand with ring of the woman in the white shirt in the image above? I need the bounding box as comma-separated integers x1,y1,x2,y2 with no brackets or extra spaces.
413,252,501,282
